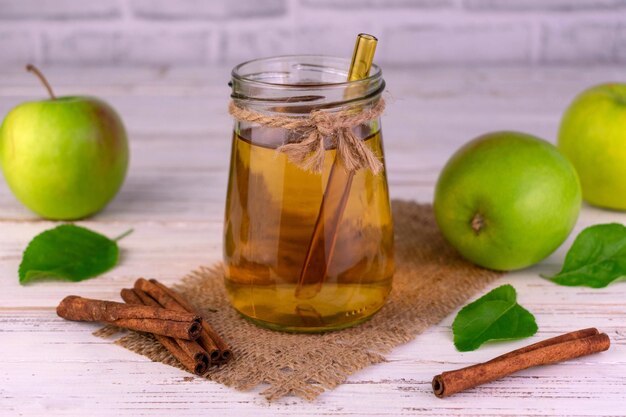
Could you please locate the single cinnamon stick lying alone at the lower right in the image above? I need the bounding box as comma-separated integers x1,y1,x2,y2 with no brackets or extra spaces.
432,329,611,398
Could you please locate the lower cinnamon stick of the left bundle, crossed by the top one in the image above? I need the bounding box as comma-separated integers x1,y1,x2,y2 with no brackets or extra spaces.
120,288,209,375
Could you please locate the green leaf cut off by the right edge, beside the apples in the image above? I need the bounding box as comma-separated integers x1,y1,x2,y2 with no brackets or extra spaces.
544,223,626,288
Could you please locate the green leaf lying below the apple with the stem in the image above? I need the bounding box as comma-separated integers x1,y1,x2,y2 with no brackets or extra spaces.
19,224,126,284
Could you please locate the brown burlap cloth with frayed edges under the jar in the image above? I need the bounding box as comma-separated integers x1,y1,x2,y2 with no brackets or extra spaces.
99,200,500,400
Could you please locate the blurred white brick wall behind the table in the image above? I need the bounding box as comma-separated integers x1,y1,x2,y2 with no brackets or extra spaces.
0,0,626,67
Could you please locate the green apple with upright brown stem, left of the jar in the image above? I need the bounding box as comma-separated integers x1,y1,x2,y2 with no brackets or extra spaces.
0,66,128,220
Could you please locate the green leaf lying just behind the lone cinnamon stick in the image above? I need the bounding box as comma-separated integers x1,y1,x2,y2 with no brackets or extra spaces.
452,284,537,352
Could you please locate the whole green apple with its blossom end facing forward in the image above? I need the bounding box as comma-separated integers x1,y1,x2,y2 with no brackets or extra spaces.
434,132,581,270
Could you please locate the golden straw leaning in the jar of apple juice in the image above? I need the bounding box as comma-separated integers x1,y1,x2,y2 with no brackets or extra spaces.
296,33,378,299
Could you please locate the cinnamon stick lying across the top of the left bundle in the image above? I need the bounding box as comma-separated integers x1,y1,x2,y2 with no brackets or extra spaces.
57,295,202,340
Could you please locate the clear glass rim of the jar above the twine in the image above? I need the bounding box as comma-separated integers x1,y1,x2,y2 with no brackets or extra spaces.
231,54,382,89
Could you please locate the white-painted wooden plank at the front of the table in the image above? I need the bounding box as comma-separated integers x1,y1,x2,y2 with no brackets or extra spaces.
0,315,626,415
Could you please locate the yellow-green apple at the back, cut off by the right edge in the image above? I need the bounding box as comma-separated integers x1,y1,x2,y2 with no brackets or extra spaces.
558,84,626,210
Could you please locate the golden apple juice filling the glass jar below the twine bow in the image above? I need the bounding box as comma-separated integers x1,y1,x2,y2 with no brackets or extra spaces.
224,126,394,332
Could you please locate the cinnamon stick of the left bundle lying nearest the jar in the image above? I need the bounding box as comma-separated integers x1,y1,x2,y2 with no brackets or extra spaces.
135,278,232,362
